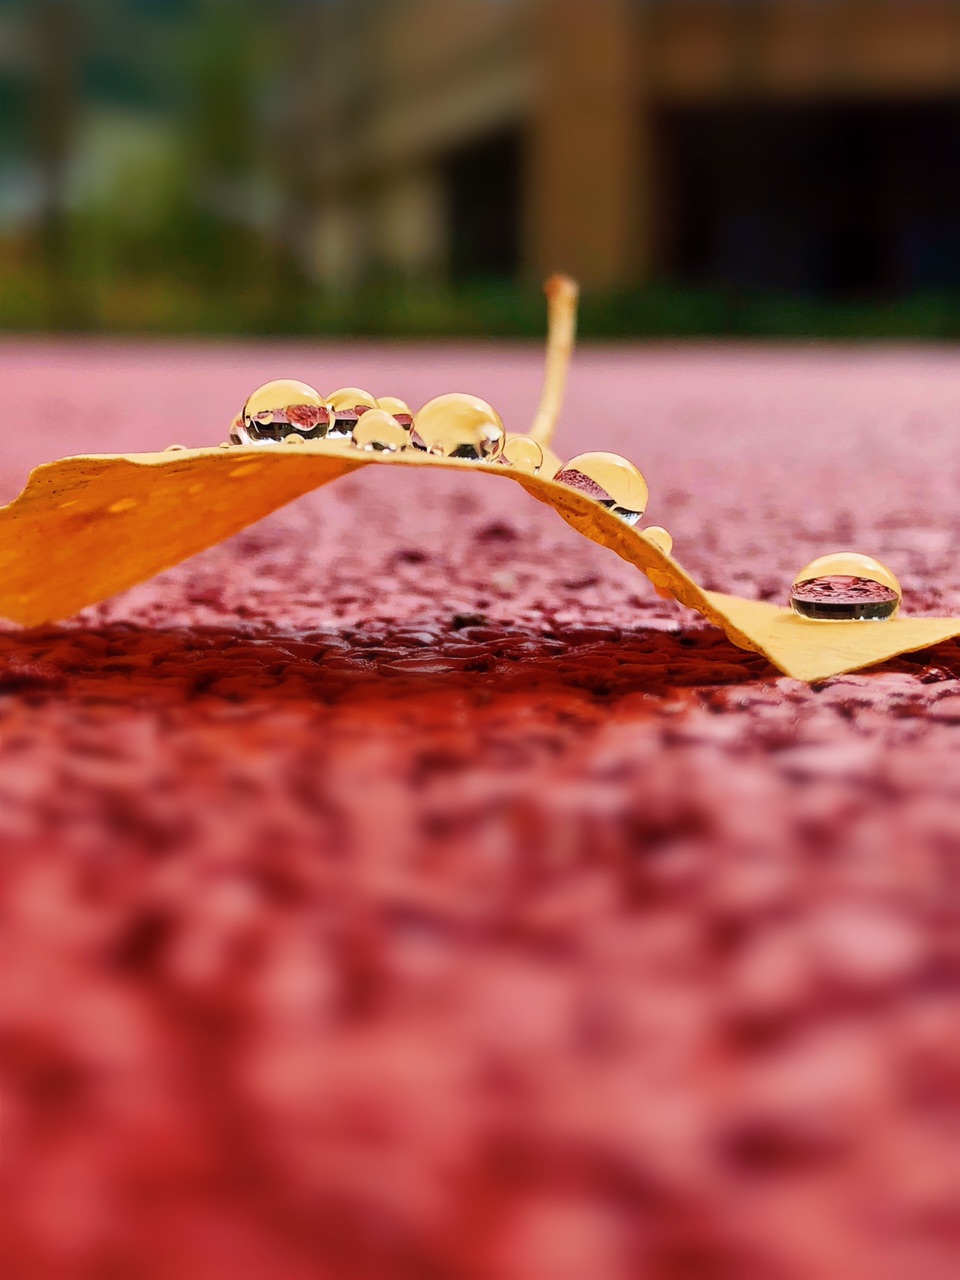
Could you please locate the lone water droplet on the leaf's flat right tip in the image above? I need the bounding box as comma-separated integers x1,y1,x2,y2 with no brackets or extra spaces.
790,552,902,622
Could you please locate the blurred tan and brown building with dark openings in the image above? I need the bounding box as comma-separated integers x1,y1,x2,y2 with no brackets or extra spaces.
303,0,960,294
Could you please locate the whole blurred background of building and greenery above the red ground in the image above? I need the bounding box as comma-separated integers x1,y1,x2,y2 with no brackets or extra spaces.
0,0,960,338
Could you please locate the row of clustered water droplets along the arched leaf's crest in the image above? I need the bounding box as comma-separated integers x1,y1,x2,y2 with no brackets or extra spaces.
229,379,672,540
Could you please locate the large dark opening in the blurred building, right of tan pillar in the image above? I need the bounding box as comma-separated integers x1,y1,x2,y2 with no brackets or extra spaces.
660,102,960,297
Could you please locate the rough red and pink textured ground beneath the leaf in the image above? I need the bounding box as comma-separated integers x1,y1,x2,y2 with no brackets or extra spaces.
0,342,960,1280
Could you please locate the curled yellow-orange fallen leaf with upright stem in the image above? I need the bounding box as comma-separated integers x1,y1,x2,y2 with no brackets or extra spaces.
0,280,960,681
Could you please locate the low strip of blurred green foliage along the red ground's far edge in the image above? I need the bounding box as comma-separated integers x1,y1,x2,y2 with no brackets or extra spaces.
0,257,960,342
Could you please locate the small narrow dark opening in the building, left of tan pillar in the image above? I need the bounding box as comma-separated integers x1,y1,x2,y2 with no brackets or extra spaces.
444,131,522,282
